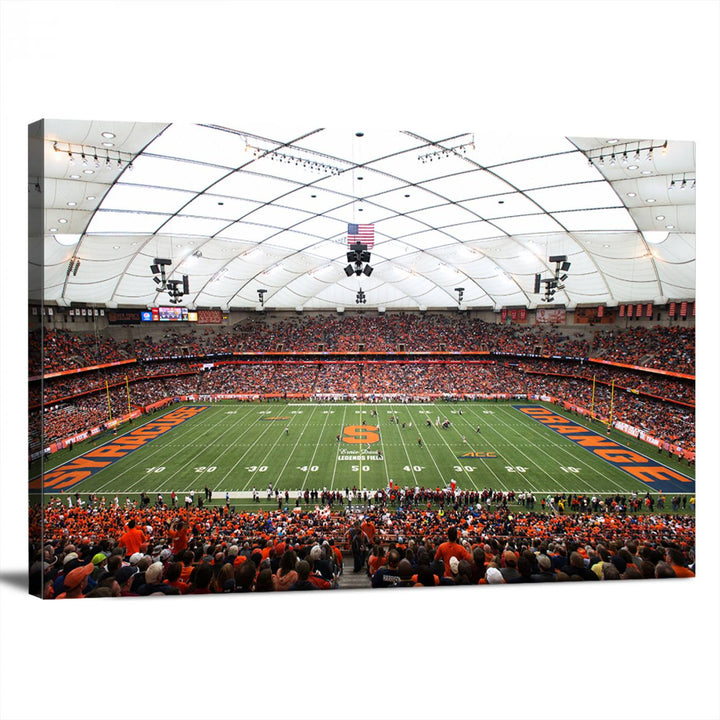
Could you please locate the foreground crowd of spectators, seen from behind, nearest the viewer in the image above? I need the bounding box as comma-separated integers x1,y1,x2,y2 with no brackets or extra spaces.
30,496,695,599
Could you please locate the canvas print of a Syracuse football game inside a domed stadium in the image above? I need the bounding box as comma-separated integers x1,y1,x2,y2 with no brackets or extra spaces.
27,119,696,600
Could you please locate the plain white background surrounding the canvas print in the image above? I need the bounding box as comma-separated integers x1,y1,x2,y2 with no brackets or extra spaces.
0,2,720,720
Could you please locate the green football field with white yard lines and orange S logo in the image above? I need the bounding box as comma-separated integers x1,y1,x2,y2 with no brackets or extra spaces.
33,401,695,505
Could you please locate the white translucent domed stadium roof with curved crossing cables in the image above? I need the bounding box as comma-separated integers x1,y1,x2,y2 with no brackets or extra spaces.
44,121,695,307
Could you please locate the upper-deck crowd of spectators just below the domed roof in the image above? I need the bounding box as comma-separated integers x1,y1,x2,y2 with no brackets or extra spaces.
30,320,695,376
